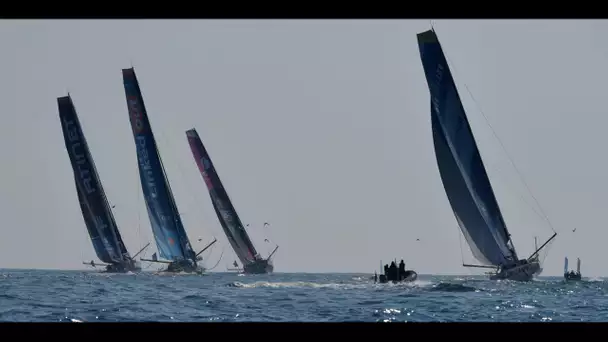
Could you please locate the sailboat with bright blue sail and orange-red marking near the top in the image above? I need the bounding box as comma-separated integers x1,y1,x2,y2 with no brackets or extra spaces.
122,68,217,274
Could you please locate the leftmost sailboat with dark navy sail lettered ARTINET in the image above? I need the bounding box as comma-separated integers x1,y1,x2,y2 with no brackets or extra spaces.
57,94,149,273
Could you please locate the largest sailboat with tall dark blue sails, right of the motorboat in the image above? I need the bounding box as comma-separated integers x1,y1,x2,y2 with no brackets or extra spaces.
417,29,557,281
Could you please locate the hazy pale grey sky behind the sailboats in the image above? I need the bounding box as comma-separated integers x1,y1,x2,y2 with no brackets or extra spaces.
0,20,608,276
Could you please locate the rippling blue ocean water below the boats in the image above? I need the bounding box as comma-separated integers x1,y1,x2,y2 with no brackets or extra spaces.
0,270,608,322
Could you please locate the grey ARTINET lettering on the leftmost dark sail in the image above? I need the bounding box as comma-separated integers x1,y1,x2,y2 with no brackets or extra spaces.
62,118,97,194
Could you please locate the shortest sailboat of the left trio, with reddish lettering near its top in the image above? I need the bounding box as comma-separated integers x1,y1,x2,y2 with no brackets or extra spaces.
186,128,279,274
